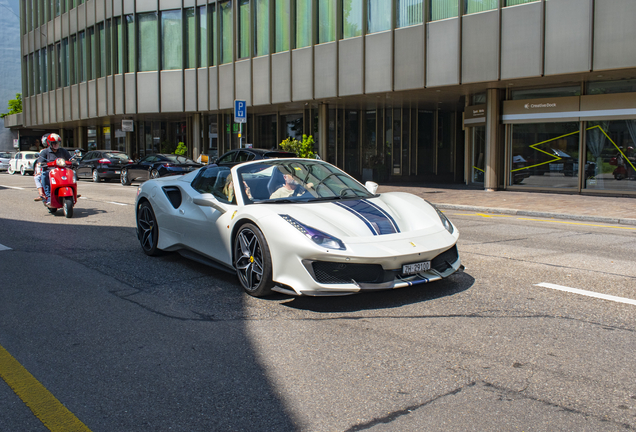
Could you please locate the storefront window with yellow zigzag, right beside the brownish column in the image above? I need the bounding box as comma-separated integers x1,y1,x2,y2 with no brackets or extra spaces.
509,122,580,189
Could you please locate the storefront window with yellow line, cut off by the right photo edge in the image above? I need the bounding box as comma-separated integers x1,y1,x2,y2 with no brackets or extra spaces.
583,120,636,192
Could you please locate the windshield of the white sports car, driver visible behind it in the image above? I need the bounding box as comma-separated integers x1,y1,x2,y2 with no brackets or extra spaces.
237,159,373,204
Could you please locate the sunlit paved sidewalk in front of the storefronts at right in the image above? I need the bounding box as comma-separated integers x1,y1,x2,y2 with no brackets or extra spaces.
378,185,636,225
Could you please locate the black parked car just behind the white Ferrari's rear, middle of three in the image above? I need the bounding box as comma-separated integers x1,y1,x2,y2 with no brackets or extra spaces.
120,154,203,186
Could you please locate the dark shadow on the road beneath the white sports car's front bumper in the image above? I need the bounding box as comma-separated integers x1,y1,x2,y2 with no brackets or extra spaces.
282,271,475,313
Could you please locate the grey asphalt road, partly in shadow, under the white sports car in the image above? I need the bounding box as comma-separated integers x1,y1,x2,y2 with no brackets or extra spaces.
0,173,636,431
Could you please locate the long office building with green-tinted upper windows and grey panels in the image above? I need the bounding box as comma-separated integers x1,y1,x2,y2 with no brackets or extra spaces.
21,0,636,195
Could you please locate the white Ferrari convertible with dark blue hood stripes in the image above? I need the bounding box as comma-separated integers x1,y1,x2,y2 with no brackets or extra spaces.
136,158,463,296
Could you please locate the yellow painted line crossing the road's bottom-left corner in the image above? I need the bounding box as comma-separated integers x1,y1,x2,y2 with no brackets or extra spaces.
0,345,90,432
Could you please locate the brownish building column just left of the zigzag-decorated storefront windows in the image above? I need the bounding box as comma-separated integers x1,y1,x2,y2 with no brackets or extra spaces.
484,89,501,191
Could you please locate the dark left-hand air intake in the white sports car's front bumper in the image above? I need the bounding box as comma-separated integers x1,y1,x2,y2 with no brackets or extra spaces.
312,261,384,284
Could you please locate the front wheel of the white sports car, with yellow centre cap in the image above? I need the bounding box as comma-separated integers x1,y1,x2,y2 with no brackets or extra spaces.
234,223,274,297
